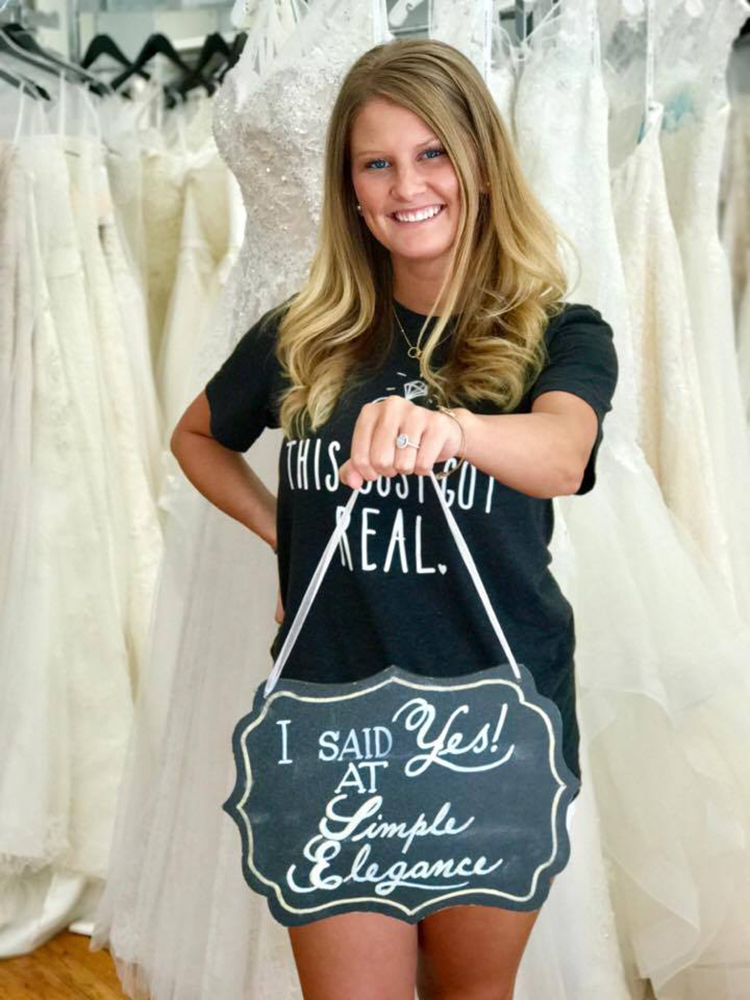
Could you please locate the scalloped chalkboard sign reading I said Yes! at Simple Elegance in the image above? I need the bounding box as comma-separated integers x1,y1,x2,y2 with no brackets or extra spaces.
223,664,579,926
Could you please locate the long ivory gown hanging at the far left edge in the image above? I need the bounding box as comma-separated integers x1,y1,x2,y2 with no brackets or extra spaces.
0,92,135,956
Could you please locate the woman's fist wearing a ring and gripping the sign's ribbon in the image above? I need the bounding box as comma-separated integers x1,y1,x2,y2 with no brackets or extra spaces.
339,396,461,490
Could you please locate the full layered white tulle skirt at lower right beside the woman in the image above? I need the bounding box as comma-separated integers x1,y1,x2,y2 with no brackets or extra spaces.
561,448,750,1000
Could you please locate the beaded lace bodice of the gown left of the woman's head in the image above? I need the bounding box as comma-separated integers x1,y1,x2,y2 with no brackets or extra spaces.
201,0,385,382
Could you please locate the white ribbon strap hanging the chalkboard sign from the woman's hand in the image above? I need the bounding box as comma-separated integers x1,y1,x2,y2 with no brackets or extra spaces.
263,472,521,697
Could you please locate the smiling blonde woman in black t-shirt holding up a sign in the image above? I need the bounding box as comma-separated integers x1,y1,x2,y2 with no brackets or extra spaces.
172,40,617,1000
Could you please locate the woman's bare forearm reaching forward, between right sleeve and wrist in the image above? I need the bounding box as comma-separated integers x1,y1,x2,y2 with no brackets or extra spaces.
453,408,581,498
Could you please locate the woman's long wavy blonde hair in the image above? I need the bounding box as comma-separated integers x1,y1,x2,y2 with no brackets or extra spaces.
273,39,567,438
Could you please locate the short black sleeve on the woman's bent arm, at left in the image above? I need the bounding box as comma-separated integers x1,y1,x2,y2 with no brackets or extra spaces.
205,313,281,451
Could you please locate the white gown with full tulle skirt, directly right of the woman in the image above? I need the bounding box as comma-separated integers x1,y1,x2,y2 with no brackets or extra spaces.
515,3,750,1000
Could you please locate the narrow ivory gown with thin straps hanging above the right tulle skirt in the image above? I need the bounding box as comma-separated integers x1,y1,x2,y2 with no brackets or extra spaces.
612,103,733,594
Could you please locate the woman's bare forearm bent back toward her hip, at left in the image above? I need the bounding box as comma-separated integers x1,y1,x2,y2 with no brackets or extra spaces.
171,427,276,549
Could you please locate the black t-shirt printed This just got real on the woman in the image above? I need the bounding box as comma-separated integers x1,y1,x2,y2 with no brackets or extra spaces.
206,303,617,775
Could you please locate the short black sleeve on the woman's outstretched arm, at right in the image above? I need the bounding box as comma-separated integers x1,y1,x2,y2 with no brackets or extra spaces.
530,303,618,494
